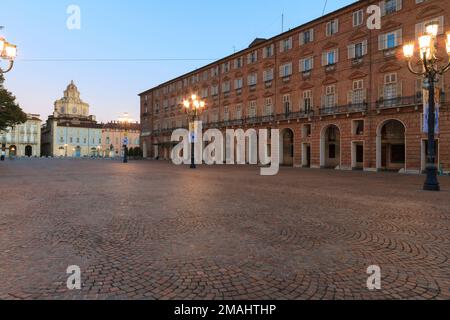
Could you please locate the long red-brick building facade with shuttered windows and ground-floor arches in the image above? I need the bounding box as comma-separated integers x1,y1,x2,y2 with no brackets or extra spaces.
140,0,450,172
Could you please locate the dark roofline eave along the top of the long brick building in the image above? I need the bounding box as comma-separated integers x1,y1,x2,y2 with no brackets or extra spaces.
138,0,368,96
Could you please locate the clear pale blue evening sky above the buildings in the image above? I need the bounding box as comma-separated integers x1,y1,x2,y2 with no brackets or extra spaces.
0,0,354,121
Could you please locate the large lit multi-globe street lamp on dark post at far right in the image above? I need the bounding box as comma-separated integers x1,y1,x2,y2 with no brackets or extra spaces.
403,23,450,191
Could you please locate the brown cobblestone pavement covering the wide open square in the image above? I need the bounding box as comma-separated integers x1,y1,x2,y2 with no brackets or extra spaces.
0,159,450,299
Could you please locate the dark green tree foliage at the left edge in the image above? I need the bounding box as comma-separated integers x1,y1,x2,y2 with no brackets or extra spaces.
0,73,27,131
